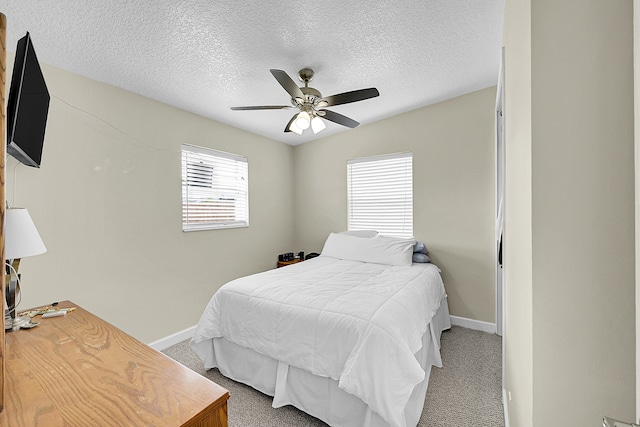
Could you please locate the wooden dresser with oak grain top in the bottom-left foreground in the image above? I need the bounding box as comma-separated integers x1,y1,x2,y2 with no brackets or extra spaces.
0,301,229,427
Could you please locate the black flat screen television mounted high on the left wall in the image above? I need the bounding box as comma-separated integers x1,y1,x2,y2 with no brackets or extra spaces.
7,32,50,168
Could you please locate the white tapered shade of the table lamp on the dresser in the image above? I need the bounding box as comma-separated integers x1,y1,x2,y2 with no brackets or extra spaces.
4,208,47,259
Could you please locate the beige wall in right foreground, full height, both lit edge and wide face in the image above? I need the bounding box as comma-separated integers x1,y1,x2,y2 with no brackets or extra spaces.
505,0,635,426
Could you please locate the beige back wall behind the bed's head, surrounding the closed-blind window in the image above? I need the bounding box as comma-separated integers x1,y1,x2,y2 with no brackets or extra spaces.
293,87,496,323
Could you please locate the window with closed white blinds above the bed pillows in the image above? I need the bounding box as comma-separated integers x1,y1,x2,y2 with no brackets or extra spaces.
347,153,413,237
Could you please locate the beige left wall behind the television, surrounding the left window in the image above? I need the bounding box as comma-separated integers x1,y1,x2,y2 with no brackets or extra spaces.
6,62,293,342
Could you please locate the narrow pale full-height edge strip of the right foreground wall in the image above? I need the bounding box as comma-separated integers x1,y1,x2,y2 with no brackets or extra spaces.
503,0,532,427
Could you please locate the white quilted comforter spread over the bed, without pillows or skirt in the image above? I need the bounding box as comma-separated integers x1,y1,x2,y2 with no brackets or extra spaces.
191,256,445,427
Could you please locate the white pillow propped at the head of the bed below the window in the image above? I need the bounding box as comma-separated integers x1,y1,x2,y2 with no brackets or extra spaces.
321,233,416,265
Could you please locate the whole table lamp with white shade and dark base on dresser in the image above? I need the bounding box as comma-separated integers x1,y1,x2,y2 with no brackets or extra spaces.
4,208,47,330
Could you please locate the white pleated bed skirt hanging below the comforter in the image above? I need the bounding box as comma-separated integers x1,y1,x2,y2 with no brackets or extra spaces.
198,296,451,427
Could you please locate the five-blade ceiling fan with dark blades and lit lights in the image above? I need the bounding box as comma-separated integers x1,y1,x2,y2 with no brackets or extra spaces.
231,68,380,135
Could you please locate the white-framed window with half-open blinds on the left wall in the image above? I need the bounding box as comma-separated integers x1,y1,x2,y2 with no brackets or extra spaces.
182,144,249,231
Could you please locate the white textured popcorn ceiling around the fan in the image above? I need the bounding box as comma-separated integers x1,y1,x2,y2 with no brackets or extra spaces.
0,0,504,145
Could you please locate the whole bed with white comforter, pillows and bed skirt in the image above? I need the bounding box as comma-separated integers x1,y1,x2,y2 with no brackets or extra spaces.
191,233,451,427
